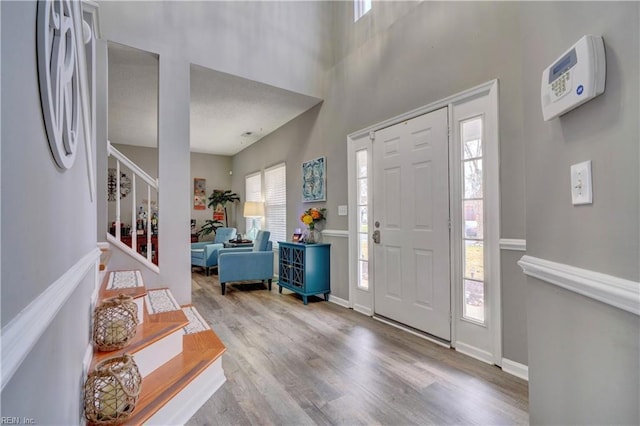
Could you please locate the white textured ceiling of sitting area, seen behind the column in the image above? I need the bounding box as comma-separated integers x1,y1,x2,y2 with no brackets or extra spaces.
109,43,320,155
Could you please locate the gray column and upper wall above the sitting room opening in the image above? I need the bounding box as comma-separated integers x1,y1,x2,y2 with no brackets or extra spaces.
98,1,338,304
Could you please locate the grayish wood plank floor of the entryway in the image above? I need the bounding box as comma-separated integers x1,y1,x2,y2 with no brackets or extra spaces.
188,272,529,425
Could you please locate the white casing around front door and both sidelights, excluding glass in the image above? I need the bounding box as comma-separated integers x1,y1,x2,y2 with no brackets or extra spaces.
347,80,502,365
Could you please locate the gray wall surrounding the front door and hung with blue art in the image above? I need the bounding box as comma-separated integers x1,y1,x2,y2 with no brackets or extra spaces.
233,2,528,364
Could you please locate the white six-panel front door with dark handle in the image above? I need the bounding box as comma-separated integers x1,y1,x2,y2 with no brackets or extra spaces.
369,108,451,341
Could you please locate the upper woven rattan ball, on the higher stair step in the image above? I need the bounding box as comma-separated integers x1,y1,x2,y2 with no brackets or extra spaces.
93,294,138,351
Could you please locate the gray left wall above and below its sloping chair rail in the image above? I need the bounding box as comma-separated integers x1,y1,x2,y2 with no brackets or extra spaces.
0,2,96,424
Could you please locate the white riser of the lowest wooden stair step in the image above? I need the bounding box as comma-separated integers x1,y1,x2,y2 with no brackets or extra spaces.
145,357,227,425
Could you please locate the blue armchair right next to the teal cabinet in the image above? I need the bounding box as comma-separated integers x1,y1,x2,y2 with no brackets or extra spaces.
218,231,273,294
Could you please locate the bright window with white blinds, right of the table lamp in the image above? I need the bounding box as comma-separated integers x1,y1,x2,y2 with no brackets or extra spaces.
264,163,287,244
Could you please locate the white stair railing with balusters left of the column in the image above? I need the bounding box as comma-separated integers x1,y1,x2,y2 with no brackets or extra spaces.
107,141,159,269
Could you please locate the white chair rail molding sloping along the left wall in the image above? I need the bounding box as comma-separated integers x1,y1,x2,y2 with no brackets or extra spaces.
2,247,101,389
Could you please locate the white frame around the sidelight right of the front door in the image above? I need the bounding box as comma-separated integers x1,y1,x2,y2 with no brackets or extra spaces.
451,81,502,365
